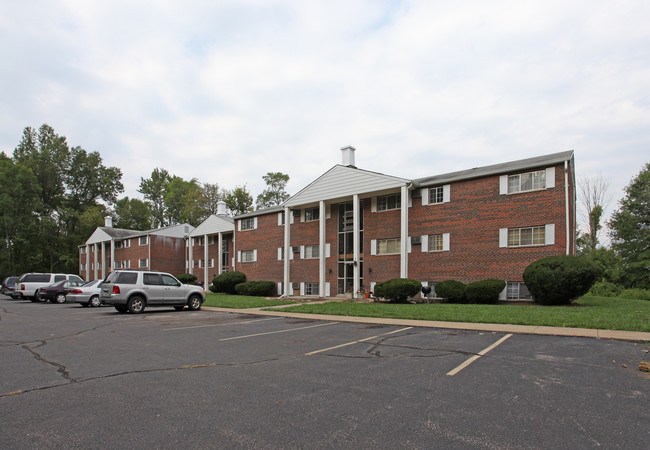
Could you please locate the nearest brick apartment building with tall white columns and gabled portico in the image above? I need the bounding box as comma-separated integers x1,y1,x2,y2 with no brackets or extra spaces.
233,147,576,299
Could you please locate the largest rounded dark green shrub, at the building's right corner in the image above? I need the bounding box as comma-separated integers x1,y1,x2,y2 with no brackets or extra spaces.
524,255,602,305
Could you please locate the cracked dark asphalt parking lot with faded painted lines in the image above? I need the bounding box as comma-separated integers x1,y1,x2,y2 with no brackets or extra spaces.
0,297,650,448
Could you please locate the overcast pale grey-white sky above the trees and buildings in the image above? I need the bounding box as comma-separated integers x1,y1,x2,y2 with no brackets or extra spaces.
0,0,650,229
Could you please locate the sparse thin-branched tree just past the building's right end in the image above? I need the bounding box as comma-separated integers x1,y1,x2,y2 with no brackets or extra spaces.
578,175,611,253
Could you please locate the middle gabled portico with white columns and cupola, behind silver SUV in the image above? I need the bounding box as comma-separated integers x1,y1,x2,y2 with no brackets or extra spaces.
188,202,235,285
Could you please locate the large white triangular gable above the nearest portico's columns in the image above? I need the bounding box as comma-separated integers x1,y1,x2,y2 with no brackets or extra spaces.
284,165,410,207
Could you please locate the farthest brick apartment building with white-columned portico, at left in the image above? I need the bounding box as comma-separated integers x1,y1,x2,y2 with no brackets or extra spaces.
79,217,194,281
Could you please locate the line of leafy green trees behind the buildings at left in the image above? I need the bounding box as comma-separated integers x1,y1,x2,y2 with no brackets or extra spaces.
0,124,289,279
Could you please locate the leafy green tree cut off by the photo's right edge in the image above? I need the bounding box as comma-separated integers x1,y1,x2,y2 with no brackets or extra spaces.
609,163,650,289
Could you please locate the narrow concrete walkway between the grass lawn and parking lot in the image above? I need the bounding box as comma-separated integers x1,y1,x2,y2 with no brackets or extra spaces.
203,305,650,342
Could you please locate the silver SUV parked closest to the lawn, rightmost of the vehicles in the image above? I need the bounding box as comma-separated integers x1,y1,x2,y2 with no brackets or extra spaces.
99,270,205,314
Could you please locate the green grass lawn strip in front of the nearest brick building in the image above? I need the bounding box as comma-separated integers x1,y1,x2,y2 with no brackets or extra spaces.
272,297,650,332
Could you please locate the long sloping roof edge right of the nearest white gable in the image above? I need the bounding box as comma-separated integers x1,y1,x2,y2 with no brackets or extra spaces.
413,150,573,186
